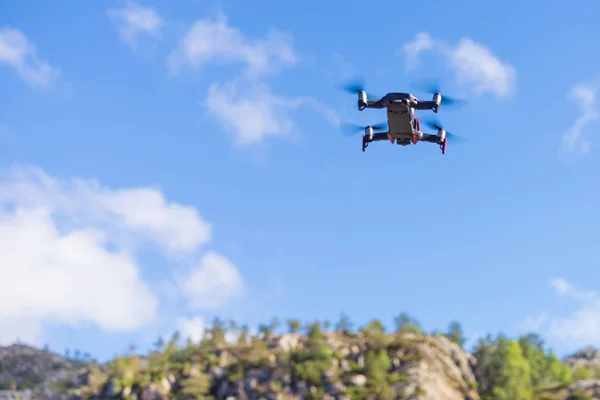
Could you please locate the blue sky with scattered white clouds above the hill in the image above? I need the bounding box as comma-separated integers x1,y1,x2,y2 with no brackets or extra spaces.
0,0,600,359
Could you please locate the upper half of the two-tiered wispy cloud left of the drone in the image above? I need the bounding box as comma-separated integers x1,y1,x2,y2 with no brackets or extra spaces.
168,15,298,77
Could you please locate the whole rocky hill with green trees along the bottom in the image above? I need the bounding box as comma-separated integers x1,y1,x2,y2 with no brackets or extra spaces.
0,321,600,400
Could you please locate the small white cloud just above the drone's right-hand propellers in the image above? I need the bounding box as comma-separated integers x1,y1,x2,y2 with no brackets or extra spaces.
403,32,517,98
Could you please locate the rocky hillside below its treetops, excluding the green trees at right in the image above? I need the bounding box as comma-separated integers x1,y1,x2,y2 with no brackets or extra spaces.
0,334,479,400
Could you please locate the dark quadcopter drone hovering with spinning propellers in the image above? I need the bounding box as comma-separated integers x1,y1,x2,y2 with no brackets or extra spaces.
345,79,462,154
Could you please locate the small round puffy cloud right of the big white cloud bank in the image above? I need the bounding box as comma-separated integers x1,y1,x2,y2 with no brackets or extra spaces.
182,251,244,309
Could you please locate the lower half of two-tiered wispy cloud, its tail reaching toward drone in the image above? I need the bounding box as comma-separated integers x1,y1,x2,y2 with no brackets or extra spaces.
205,81,340,146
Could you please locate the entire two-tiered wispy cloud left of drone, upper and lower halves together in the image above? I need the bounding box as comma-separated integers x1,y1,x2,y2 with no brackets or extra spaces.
167,14,339,146
